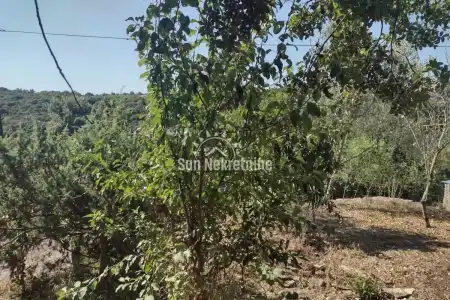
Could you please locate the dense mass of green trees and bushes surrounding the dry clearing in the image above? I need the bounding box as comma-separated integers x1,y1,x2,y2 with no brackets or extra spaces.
0,0,450,300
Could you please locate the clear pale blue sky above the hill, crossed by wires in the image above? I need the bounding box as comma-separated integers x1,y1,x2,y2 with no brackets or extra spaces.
0,0,450,94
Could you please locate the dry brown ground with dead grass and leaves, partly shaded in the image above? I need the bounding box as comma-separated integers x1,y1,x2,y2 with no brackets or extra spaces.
0,197,450,300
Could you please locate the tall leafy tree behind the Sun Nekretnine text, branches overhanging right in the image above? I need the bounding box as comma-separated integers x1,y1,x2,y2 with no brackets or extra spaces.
57,0,450,300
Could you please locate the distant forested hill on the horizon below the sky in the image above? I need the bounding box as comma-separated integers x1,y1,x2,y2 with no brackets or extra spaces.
0,87,145,133
